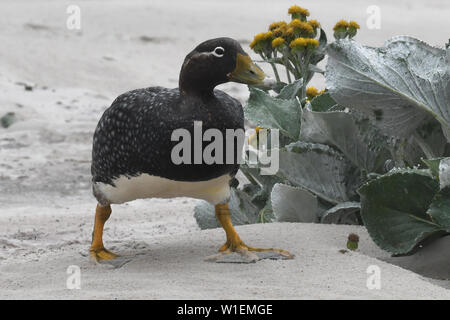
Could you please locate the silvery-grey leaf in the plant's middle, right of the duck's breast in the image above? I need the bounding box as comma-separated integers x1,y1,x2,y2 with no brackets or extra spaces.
279,141,352,203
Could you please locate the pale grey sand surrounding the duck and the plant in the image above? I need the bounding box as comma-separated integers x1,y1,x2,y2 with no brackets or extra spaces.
0,0,450,299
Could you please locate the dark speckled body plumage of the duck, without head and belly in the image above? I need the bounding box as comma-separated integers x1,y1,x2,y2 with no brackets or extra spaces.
91,87,244,184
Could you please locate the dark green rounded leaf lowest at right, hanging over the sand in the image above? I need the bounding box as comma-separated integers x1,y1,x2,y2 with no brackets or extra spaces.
359,169,444,254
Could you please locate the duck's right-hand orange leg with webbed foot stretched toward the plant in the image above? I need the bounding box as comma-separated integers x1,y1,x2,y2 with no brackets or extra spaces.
215,203,293,259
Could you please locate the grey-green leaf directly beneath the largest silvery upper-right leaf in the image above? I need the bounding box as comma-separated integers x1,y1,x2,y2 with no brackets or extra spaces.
300,93,389,172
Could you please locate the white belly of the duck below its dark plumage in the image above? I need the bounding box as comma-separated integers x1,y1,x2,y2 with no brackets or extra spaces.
94,173,231,204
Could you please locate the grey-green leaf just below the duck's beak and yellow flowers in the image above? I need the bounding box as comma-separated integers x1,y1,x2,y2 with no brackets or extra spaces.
244,87,301,140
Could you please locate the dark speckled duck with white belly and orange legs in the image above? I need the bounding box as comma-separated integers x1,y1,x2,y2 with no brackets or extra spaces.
90,37,292,262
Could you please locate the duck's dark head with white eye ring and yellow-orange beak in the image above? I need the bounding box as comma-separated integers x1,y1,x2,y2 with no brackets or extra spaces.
180,38,275,93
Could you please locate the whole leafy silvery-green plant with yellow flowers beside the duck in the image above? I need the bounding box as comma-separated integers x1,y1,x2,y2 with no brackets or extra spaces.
193,5,450,254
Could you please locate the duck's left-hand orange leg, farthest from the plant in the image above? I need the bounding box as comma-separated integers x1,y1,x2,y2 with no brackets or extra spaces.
89,205,117,261
